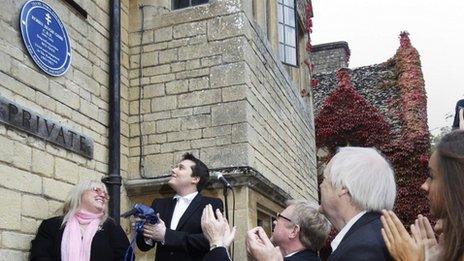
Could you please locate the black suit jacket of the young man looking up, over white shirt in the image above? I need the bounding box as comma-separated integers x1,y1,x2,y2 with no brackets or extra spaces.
137,193,223,261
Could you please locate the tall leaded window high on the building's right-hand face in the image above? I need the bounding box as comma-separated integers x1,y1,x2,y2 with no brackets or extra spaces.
277,0,298,66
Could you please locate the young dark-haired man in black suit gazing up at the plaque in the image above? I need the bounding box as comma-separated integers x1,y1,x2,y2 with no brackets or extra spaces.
137,153,223,261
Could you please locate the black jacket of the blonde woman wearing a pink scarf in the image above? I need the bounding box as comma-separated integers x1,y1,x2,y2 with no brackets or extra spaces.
30,214,129,261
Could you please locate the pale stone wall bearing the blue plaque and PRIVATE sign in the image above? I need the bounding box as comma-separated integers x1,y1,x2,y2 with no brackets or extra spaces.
0,0,128,256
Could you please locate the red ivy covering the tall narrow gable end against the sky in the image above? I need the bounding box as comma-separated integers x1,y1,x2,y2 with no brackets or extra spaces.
384,31,430,224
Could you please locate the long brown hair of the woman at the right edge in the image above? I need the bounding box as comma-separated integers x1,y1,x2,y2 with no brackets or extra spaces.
437,130,464,260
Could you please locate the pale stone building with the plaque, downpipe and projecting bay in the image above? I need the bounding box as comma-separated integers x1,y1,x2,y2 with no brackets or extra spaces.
0,0,317,260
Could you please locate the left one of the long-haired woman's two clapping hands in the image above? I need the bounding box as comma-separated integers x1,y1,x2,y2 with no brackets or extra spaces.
380,210,425,261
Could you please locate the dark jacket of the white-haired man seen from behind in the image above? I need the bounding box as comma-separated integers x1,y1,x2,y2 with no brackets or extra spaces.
329,212,393,261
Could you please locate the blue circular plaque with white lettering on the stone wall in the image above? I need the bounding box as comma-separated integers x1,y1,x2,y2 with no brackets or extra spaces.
20,0,71,76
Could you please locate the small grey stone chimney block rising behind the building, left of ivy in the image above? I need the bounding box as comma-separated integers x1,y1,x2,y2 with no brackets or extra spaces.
311,42,350,74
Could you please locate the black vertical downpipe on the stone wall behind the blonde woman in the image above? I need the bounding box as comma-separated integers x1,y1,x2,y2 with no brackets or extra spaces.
102,0,121,224
